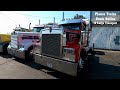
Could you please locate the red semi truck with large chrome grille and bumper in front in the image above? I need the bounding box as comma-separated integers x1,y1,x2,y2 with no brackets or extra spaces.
34,19,93,76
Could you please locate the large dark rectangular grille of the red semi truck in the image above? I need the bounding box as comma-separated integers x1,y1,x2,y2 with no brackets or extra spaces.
42,34,61,58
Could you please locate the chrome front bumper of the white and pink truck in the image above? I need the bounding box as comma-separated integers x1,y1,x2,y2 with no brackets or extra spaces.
7,46,25,59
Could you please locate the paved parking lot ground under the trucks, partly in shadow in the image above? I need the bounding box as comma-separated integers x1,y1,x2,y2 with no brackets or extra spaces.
0,49,120,80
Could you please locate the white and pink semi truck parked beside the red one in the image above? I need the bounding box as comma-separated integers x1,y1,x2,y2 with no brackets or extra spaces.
7,26,44,60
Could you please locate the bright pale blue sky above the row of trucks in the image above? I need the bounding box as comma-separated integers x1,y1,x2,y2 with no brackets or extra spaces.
0,11,90,33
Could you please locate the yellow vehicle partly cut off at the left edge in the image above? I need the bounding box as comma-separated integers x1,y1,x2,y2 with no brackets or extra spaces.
0,34,11,54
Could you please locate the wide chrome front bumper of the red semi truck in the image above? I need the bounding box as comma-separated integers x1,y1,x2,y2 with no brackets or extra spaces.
34,54,77,76
